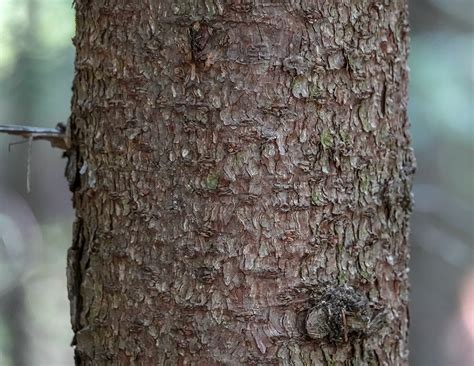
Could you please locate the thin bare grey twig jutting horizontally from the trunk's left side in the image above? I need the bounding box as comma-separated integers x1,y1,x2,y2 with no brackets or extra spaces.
0,123,69,150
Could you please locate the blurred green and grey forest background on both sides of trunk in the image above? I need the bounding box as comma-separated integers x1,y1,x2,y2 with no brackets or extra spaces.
0,0,474,366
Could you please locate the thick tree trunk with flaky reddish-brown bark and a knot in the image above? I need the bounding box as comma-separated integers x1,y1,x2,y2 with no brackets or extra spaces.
67,0,414,365
